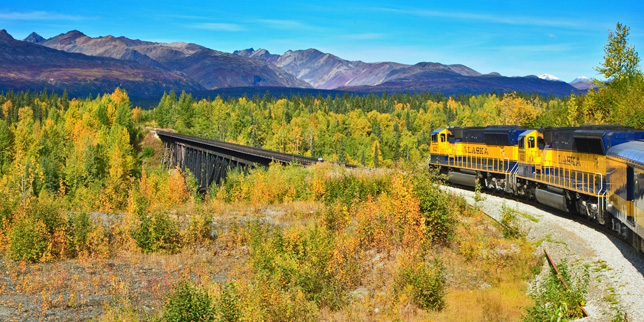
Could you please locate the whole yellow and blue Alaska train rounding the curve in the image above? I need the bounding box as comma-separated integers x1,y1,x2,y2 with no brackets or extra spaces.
428,125,644,252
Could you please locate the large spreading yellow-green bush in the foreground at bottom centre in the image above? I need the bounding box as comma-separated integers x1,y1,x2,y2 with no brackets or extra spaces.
250,225,358,309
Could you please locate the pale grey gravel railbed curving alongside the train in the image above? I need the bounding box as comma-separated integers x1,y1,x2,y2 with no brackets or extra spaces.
444,187,644,321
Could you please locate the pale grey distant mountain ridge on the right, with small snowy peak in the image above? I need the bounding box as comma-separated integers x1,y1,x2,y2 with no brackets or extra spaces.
234,48,579,95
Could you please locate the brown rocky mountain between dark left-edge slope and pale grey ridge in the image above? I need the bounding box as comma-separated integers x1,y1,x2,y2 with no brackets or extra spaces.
35,30,311,89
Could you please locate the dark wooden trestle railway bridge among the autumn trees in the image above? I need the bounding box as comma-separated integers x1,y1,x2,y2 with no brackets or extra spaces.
155,131,322,191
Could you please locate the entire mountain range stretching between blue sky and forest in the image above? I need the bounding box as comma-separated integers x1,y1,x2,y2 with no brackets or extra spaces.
0,30,585,99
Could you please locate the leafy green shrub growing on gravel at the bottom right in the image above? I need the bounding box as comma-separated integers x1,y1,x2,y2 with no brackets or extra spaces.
523,260,589,322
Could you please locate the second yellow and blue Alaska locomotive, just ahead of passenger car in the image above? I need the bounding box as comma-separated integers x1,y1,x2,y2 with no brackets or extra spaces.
517,126,644,224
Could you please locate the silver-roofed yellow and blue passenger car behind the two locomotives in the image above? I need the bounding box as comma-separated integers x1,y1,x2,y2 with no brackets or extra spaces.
606,141,644,252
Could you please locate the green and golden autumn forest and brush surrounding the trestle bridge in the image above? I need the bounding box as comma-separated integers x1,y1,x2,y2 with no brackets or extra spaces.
0,25,644,321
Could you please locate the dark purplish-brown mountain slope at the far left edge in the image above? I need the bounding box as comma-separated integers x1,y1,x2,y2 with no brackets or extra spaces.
0,30,203,98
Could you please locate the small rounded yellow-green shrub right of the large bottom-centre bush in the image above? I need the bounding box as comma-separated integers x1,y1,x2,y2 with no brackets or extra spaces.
394,256,445,311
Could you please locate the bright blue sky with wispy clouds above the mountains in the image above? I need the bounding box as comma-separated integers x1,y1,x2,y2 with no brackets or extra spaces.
0,0,644,81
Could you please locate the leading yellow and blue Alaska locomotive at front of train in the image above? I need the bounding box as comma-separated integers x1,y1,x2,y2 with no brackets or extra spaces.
429,126,525,192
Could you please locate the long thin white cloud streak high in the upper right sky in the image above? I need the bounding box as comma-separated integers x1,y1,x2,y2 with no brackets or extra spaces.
374,8,584,28
